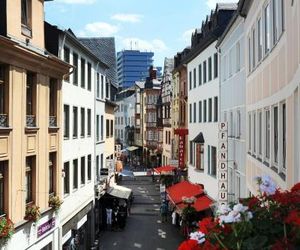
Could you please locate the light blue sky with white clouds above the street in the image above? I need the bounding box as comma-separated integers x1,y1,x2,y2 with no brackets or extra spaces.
45,0,236,66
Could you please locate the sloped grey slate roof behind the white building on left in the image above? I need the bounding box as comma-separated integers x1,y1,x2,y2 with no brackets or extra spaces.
79,37,117,85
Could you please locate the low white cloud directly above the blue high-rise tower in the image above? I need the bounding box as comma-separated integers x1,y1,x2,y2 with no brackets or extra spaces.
122,37,168,52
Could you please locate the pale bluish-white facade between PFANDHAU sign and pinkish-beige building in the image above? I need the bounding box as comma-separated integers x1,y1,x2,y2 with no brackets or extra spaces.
217,14,248,201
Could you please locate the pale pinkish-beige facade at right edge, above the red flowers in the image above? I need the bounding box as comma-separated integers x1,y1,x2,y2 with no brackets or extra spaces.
245,0,300,194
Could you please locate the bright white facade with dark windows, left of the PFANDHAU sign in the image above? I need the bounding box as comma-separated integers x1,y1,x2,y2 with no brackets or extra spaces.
187,41,219,200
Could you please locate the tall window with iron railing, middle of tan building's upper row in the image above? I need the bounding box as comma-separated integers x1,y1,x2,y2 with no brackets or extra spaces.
26,72,36,127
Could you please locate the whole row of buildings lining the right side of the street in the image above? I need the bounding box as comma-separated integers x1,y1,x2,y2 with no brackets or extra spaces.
116,0,300,207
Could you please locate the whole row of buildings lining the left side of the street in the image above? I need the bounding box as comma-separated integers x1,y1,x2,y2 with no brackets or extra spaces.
0,0,117,250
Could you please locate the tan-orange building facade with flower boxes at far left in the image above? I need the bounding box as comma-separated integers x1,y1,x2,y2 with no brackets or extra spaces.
0,0,69,249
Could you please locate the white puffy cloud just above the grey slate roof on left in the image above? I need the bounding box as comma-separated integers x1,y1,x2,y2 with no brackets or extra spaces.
78,22,119,37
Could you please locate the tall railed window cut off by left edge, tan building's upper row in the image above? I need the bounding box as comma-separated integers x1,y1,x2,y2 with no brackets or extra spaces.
0,64,8,127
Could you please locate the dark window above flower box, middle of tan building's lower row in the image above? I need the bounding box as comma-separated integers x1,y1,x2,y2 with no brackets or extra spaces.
25,156,35,204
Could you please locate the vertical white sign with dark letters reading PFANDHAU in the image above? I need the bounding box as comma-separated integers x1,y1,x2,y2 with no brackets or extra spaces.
218,122,228,205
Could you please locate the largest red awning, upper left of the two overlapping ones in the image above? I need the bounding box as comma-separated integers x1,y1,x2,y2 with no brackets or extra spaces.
167,181,204,205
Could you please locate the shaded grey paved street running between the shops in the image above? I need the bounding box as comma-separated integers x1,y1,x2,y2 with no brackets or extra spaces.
100,176,183,250
